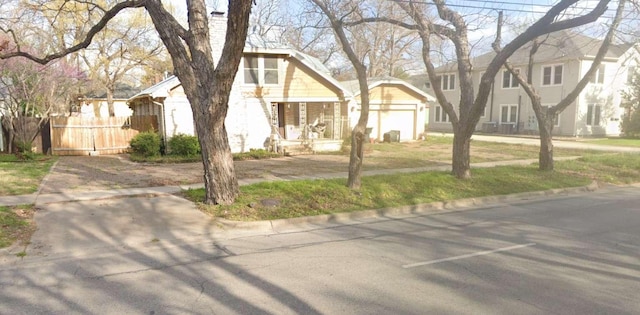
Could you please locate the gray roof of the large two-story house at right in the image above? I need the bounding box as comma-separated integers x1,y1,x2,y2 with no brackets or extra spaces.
436,30,632,72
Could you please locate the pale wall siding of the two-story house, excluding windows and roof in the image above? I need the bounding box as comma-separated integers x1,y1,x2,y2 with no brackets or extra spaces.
428,56,631,136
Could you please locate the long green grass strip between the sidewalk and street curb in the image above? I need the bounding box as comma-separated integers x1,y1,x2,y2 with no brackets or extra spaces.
183,154,640,221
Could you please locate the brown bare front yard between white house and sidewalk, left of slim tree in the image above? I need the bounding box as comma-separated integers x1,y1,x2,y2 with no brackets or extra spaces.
40,155,356,194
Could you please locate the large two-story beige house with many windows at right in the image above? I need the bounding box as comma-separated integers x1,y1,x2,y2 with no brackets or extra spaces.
412,31,638,137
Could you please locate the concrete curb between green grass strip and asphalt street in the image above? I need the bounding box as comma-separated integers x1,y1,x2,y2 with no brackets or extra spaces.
214,181,600,234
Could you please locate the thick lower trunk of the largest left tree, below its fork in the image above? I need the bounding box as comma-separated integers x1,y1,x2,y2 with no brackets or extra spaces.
193,93,240,205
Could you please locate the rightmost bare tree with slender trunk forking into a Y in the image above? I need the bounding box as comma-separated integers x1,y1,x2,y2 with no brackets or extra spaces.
494,0,626,171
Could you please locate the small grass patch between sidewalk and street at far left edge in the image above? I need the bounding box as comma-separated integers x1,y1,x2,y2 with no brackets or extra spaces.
0,205,35,248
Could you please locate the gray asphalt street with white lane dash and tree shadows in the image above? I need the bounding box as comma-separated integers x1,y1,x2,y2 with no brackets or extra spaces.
0,187,640,314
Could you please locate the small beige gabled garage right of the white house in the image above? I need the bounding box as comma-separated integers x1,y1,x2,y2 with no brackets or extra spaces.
341,77,435,141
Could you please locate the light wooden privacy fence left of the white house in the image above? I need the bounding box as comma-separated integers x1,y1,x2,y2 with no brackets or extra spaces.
50,115,158,155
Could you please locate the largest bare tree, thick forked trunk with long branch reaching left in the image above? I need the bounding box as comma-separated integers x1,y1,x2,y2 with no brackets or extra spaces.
0,0,252,204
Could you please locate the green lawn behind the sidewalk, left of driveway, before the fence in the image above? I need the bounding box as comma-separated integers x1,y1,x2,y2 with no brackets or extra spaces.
0,154,57,196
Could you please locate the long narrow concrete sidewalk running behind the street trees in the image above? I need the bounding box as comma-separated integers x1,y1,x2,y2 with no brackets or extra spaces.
0,157,579,206
